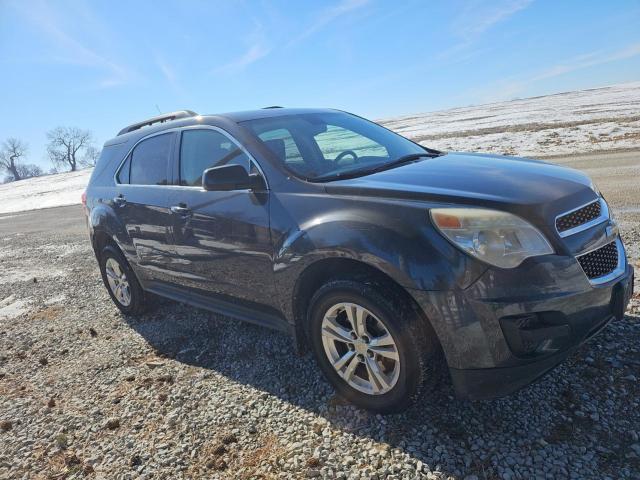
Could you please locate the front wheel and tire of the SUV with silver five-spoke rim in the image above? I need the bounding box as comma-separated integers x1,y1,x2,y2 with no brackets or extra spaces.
308,280,444,413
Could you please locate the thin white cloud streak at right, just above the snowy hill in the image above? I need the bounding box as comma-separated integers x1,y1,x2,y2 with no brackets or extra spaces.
472,42,640,103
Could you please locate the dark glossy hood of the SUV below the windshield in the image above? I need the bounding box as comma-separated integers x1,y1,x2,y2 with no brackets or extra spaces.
325,153,596,206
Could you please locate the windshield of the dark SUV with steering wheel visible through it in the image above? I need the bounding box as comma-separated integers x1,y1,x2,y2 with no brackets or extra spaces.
242,112,436,181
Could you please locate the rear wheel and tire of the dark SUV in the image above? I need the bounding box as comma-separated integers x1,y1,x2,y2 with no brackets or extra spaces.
100,245,147,315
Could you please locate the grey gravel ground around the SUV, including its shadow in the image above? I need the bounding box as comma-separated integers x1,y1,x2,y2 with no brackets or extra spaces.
0,154,640,480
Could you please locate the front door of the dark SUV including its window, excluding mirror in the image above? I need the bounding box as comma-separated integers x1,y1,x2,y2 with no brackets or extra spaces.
165,128,274,306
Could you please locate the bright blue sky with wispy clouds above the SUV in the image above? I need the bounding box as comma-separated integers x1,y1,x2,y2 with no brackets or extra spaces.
0,0,640,169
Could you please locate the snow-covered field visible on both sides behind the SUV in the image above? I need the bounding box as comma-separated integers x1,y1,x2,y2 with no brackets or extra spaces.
0,82,640,216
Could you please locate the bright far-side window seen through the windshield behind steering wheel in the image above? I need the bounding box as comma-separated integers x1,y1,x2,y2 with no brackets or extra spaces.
313,125,389,161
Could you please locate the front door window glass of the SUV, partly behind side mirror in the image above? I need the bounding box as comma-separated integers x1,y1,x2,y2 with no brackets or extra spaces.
180,130,250,187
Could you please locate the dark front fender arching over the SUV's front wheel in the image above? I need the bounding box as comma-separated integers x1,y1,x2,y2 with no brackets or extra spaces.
274,203,484,318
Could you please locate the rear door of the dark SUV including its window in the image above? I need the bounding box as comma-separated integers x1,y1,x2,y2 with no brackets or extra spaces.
113,132,177,282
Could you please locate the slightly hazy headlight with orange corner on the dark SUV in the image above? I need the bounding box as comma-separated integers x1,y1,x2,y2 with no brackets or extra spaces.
430,208,553,268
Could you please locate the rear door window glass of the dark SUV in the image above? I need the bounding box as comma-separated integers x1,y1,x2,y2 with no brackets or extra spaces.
129,133,172,185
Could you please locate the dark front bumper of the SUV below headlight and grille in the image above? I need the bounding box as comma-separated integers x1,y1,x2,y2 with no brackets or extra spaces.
412,249,634,400
